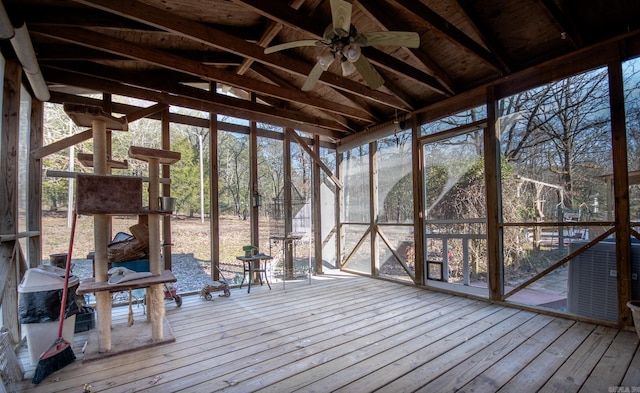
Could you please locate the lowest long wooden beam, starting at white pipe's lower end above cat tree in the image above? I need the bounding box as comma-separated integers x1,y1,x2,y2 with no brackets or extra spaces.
47,69,346,139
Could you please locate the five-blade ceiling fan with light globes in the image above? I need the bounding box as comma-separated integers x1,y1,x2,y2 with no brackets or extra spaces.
264,0,420,91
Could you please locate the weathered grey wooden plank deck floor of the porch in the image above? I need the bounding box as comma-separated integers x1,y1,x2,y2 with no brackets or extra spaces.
11,273,640,393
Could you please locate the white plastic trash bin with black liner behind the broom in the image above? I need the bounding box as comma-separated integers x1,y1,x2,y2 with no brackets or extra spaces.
18,266,79,365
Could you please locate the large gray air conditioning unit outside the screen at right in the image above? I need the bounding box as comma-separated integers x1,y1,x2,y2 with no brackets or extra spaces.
567,241,640,321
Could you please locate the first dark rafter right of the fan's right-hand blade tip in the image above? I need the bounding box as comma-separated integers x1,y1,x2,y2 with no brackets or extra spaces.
392,0,508,73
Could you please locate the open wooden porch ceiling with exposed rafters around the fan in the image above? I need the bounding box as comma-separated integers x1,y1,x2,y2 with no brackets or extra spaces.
3,0,640,141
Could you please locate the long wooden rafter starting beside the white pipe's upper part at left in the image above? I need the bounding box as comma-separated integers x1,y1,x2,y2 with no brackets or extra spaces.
32,26,373,121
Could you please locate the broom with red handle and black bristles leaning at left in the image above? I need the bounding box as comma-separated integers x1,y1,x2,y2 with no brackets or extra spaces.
31,210,77,384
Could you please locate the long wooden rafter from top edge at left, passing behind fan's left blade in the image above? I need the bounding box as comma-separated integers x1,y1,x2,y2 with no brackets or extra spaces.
75,0,404,110
